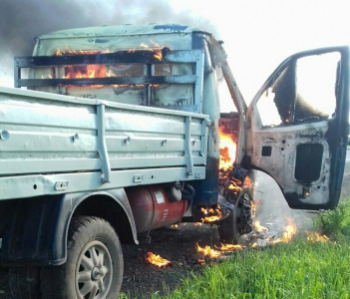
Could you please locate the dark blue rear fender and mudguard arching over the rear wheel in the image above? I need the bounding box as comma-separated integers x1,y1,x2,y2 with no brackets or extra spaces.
0,188,138,266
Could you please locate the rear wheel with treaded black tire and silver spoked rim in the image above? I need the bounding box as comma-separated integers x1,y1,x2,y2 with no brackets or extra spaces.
41,216,123,299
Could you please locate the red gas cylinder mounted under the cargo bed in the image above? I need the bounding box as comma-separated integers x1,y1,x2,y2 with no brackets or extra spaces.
125,185,188,233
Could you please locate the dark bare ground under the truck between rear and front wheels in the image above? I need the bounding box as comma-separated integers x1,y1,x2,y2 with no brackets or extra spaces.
122,223,219,298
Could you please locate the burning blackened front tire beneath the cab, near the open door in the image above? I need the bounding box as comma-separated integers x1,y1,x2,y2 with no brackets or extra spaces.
218,190,253,244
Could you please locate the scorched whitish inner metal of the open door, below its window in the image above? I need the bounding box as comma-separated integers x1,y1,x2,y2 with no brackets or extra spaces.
252,122,330,204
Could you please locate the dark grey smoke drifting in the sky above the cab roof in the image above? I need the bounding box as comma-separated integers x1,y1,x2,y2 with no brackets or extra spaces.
0,0,215,85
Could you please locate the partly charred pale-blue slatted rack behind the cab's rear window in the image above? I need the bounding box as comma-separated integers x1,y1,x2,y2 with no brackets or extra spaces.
14,48,205,113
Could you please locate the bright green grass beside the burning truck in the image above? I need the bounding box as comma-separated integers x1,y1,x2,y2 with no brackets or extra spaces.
131,200,350,299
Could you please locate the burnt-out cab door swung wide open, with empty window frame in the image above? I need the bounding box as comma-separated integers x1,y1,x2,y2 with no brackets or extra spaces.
247,47,349,210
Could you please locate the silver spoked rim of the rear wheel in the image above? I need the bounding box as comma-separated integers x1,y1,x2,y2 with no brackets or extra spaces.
75,240,113,299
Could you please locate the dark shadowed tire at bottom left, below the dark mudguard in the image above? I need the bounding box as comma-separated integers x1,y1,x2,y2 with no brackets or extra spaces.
8,267,41,299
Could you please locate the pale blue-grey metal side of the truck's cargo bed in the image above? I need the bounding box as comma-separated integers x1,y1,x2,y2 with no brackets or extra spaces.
0,87,210,203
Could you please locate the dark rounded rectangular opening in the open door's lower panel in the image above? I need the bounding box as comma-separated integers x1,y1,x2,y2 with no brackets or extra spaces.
294,143,323,182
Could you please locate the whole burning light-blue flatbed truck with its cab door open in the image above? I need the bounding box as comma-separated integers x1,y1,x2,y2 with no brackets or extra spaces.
0,25,349,298
